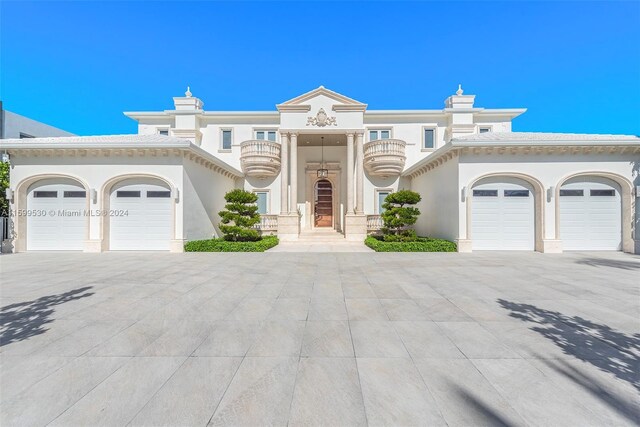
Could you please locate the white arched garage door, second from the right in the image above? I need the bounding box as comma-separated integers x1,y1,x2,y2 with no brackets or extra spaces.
471,177,535,250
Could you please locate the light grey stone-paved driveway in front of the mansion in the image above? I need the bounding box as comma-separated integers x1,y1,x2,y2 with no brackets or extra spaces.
0,253,640,426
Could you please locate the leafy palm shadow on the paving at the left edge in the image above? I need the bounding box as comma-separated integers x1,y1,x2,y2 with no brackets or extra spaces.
0,286,94,347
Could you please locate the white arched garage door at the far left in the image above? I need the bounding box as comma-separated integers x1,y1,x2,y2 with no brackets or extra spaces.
27,178,88,251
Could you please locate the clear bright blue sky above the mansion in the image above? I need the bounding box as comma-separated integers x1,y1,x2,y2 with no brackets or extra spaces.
0,1,640,135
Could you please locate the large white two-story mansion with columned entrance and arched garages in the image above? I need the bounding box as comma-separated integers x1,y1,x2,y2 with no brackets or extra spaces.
0,86,640,252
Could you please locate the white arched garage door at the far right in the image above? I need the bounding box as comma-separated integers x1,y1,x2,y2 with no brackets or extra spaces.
558,177,622,251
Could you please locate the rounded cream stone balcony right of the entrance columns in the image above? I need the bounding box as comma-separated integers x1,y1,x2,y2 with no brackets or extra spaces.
364,139,407,177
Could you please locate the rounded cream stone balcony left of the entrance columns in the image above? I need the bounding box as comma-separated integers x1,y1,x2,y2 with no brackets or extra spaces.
240,139,280,178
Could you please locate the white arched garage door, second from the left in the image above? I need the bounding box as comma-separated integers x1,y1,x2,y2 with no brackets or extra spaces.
109,179,173,251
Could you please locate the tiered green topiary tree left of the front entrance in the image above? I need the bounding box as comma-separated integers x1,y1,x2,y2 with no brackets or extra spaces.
218,189,260,242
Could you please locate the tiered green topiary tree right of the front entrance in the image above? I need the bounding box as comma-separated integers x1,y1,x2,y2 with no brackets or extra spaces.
381,190,422,242
